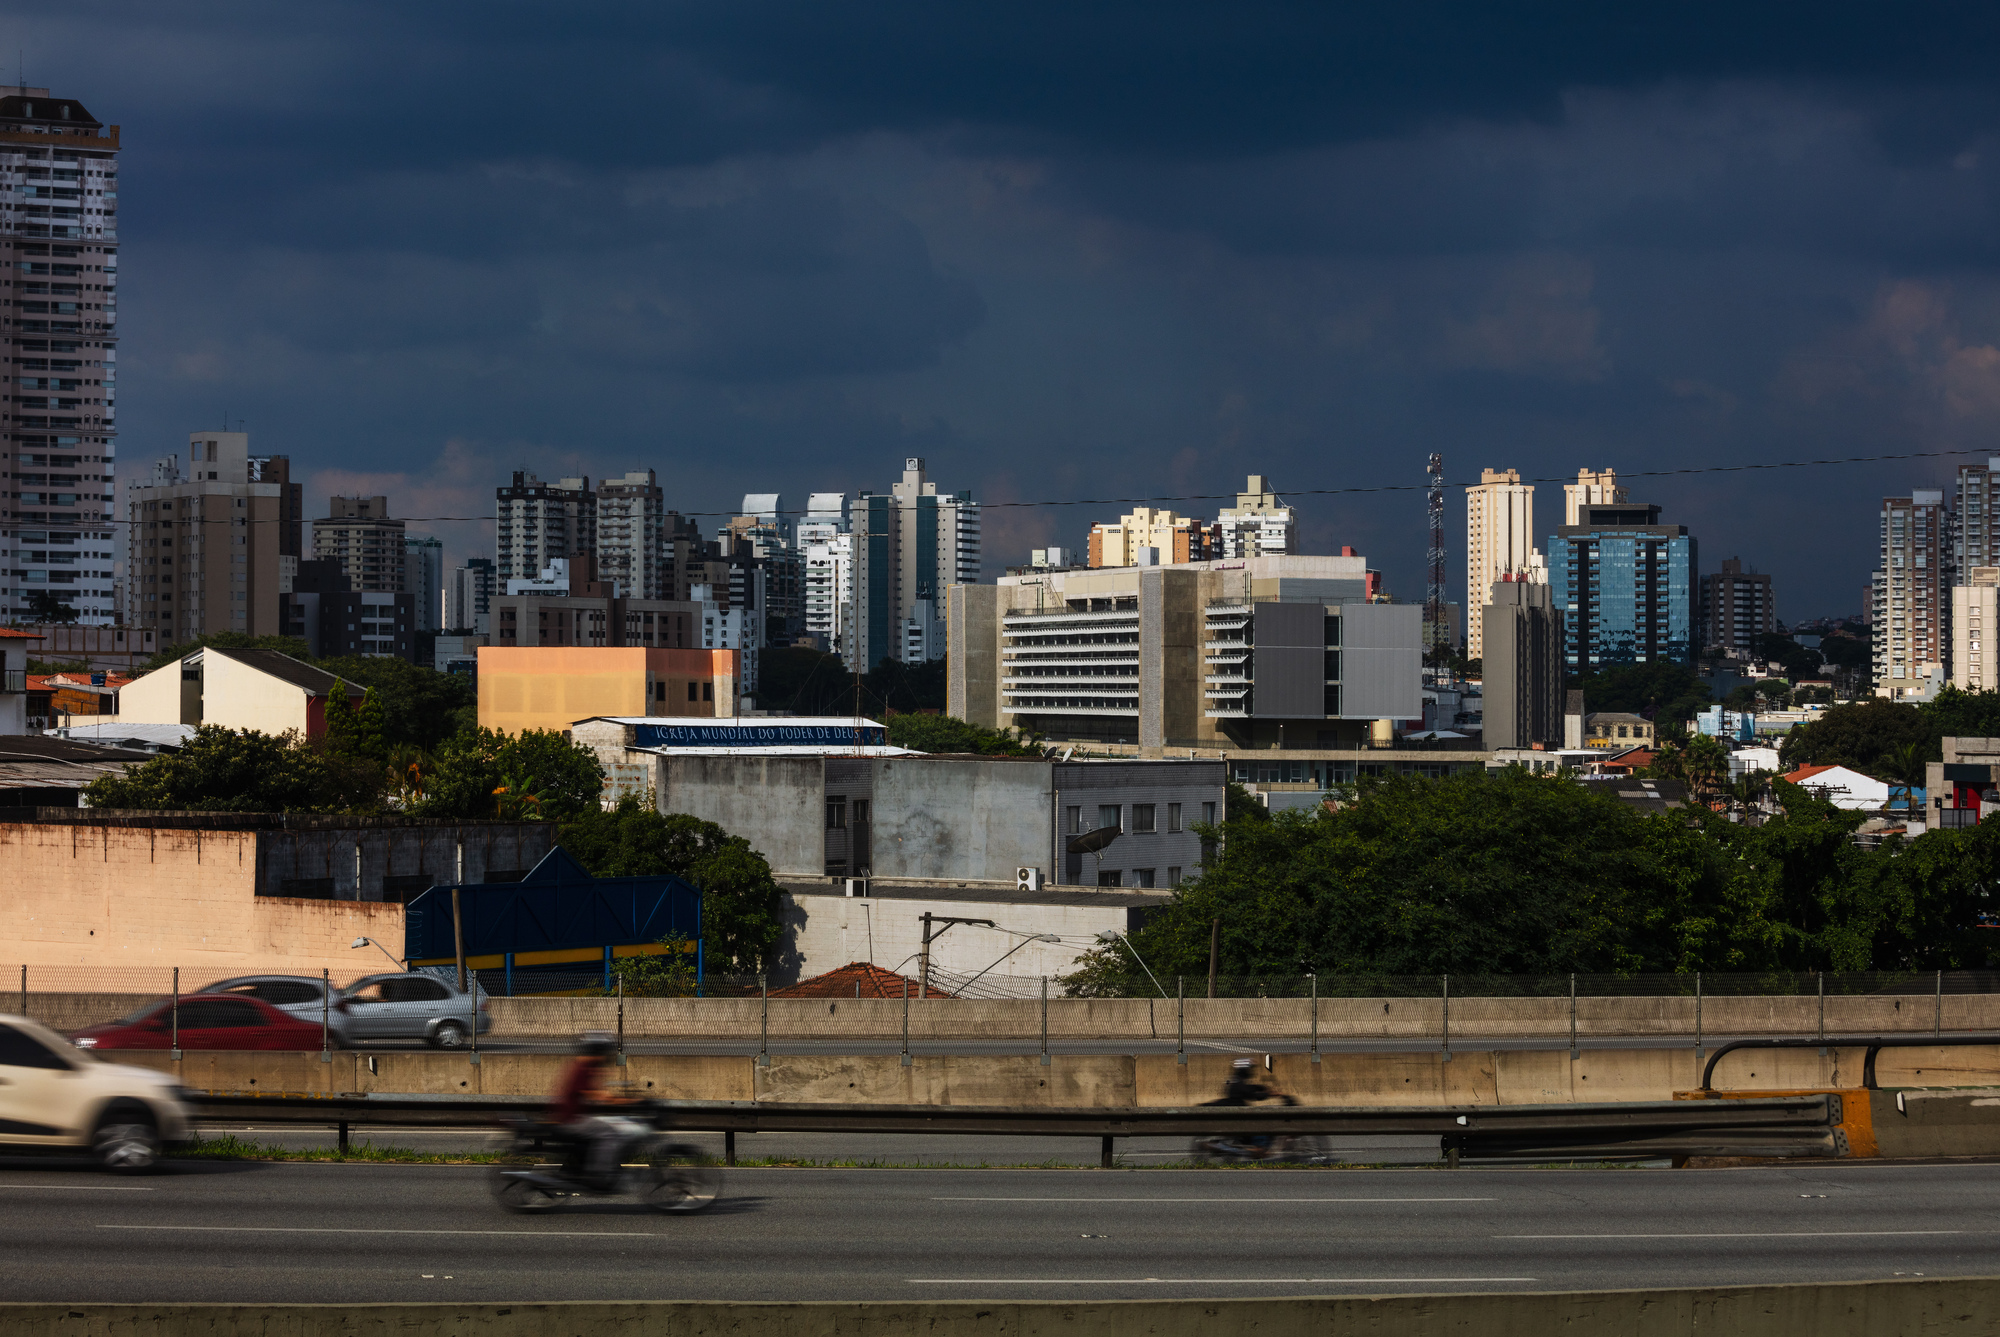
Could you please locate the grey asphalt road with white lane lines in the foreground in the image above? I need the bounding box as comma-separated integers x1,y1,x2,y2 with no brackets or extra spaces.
0,1161,2000,1303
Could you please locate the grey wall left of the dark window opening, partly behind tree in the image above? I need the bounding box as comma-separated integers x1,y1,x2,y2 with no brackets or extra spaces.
656,757,826,877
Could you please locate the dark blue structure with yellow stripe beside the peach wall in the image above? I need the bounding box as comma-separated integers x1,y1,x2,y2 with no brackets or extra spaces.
402,845,704,995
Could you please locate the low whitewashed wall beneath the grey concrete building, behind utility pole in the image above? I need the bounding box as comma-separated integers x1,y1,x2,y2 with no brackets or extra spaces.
788,893,1132,997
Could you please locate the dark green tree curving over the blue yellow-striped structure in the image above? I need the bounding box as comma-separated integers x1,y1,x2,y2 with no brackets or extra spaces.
560,795,784,975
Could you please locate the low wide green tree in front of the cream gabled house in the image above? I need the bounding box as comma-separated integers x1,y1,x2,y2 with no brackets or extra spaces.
84,725,384,813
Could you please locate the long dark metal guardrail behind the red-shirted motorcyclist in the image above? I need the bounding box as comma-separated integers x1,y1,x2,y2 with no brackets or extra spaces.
188,1091,1840,1165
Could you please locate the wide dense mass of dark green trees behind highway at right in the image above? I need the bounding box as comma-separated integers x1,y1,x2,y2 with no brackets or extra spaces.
1068,769,2000,995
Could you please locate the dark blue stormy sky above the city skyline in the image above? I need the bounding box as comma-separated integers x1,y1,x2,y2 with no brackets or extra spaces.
35,0,2000,618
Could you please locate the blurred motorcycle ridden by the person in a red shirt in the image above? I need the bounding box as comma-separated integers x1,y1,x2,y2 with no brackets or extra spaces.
492,1107,722,1213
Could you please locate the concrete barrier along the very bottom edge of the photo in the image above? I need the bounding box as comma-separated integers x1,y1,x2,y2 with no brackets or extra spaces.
0,1277,2000,1337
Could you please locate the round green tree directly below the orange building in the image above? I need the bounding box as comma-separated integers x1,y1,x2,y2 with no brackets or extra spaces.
410,729,604,821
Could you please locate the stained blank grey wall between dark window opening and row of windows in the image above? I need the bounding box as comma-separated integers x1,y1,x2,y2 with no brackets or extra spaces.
872,757,1052,879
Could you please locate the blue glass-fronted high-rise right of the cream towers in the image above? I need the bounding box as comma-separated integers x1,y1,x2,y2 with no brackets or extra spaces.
1548,502,1700,675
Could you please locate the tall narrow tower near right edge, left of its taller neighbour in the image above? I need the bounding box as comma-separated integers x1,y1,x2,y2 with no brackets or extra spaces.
1872,488,1952,701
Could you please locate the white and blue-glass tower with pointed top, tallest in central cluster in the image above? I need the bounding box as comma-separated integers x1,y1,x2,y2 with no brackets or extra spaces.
844,456,980,669
